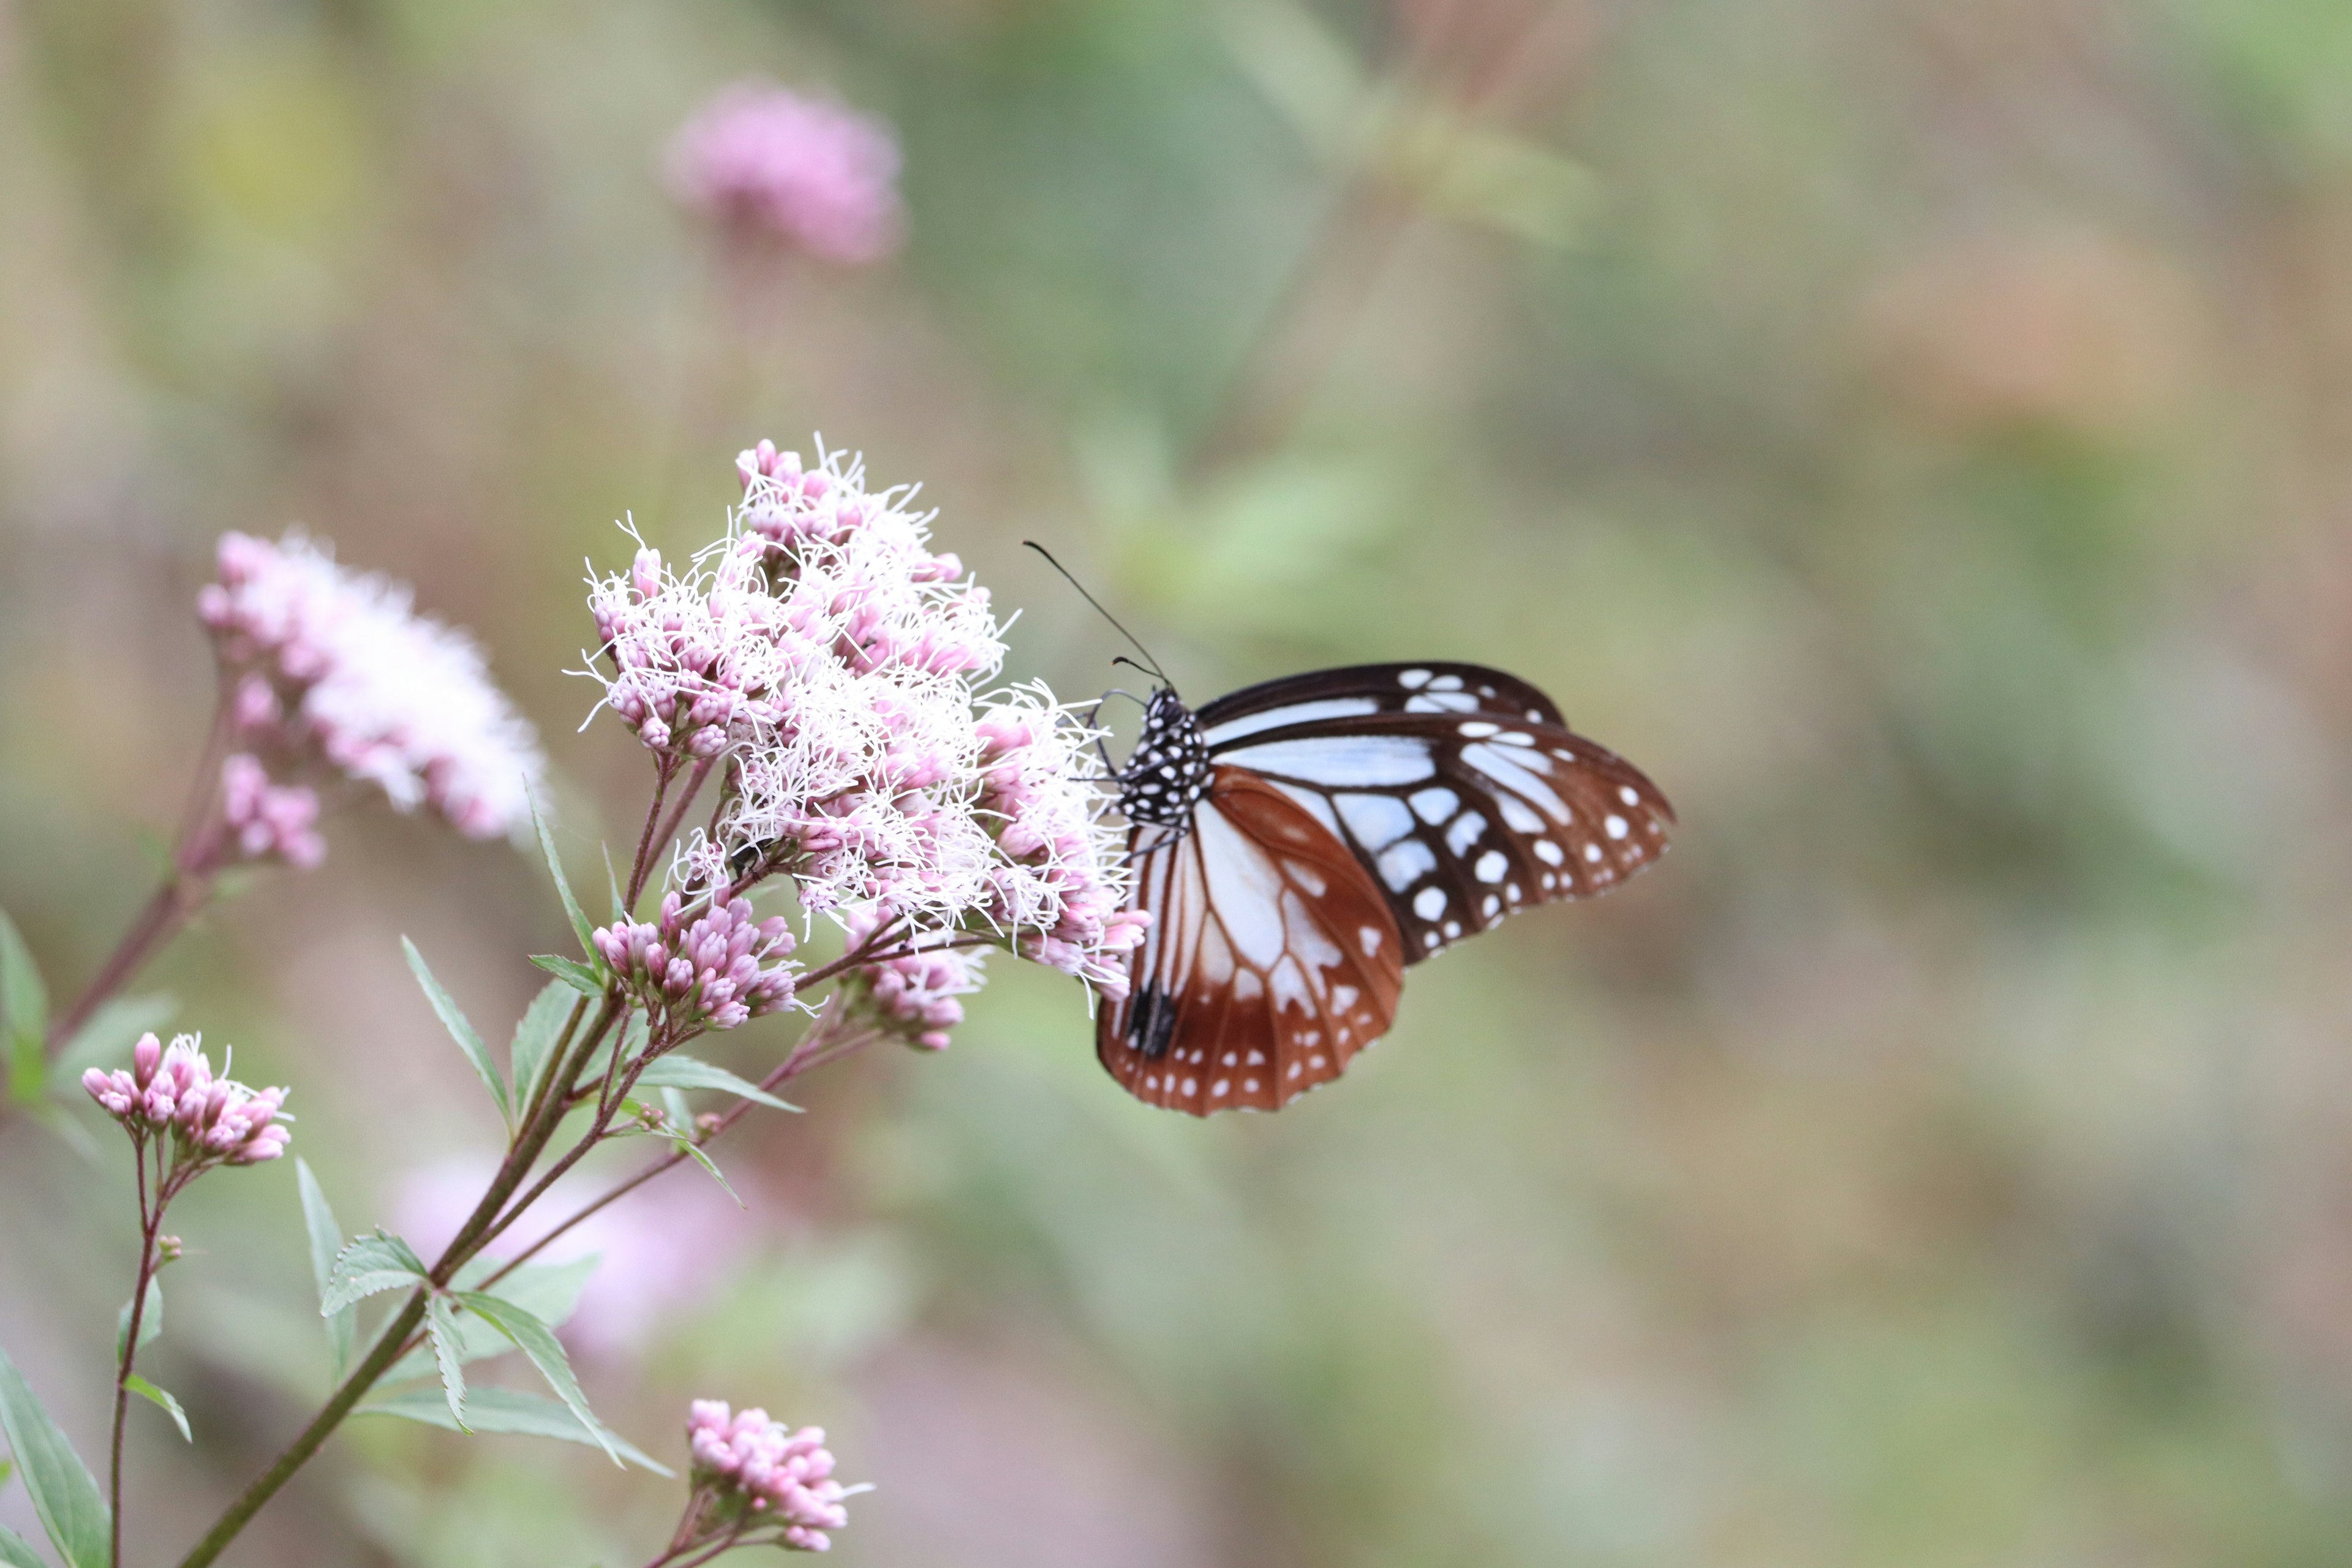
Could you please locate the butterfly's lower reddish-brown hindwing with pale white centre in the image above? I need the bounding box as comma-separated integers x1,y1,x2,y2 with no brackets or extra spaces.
1096,766,1406,1117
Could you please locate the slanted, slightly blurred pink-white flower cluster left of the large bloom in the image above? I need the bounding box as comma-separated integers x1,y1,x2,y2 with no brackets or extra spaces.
198,533,546,861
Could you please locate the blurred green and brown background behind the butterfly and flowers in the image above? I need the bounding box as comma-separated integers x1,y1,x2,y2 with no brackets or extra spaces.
0,0,2352,1568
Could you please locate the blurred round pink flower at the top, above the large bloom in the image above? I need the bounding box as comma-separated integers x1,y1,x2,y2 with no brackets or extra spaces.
670,82,905,263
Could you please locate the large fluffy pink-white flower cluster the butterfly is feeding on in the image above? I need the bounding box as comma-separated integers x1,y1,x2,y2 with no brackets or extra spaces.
588,442,1140,987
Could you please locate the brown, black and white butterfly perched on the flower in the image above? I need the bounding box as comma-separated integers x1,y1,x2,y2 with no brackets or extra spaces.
1096,663,1675,1117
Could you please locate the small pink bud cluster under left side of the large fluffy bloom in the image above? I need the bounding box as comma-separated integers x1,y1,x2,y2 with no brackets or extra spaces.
593,889,797,1030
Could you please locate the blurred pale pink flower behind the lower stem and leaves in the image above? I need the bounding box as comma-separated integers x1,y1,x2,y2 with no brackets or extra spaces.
390,1154,760,1359
